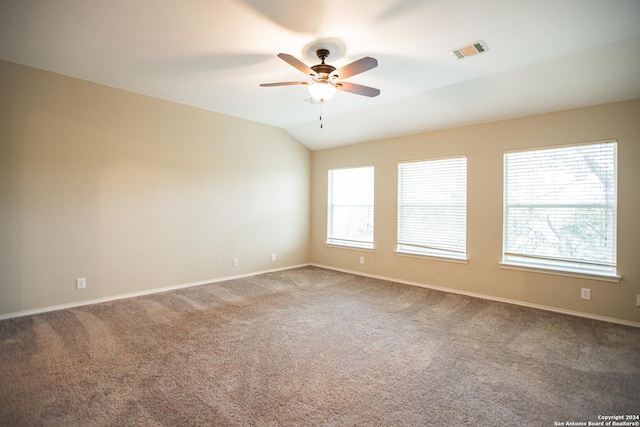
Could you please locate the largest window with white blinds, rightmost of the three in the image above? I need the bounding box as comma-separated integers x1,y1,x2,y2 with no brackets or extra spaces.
503,142,617,277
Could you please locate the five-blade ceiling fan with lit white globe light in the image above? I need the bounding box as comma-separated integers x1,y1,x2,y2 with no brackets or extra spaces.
260,49,380,103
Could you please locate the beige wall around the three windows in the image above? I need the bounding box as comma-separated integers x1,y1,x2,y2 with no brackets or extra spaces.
310,100,640,324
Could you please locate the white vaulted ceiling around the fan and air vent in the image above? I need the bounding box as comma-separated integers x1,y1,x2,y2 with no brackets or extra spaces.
0,0,640,150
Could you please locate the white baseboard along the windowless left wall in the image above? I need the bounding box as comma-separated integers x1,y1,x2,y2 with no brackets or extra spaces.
0,264,309,320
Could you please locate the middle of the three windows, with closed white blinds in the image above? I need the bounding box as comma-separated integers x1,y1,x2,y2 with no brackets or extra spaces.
397,157,467,260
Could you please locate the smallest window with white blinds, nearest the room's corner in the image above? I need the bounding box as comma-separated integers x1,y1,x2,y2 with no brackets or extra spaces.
327,166,373,249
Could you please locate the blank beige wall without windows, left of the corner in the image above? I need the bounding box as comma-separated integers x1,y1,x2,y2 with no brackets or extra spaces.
0,62,310,315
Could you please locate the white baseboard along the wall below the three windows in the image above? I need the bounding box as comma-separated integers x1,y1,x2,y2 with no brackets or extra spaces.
309,263,640,328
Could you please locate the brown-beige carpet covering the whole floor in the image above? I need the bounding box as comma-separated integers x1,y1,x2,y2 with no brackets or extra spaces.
0,267,640,426
